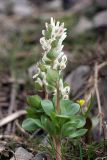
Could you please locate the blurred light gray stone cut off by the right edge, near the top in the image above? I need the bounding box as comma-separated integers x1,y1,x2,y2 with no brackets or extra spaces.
93,10,107,27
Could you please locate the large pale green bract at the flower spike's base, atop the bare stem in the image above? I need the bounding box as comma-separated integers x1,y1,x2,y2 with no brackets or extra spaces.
47,69,59,85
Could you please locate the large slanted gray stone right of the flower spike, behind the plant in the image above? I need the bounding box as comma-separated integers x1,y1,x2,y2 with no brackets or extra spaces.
65,65,90,95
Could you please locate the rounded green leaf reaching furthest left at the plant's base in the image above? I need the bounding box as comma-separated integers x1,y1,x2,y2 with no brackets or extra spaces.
22,118,39,131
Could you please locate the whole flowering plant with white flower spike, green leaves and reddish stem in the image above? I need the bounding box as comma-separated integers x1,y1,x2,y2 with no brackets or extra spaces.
22,18,87,160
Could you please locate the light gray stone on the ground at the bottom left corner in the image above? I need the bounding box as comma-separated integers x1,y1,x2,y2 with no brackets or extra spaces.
10,147,33,160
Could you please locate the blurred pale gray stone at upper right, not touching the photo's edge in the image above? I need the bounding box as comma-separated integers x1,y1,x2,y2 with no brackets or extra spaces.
73,17,93,34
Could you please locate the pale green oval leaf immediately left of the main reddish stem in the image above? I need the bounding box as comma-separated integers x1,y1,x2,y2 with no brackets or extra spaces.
41,100,54,116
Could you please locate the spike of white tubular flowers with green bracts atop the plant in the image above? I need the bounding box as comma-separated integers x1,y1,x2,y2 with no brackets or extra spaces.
33,18,70,99
